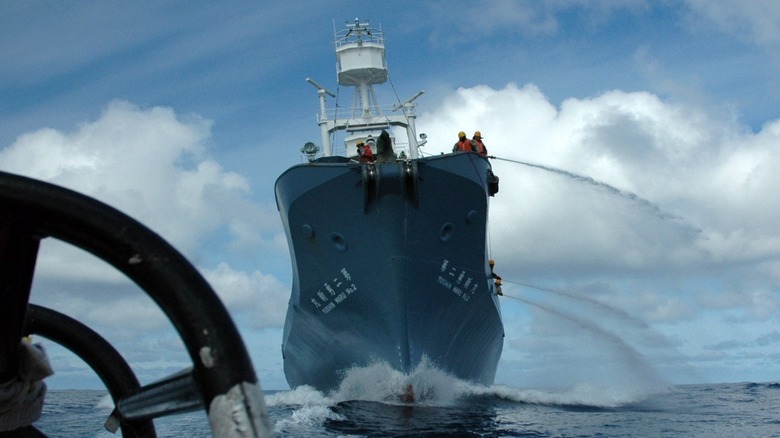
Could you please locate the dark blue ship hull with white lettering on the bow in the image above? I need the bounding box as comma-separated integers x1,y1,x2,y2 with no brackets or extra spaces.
276,153,504,391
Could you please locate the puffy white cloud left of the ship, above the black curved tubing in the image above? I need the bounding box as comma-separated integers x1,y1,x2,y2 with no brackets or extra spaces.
0,101,279,268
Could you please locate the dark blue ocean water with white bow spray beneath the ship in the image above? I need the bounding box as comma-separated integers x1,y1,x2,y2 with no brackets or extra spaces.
30,369,780,438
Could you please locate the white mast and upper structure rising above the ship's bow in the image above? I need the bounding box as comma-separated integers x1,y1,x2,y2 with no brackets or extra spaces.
306,18,423,159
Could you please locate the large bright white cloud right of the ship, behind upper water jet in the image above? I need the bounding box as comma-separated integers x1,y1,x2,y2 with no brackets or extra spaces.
419,84,780,280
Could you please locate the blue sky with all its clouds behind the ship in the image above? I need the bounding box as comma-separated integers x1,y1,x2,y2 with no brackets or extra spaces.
0,0,780,395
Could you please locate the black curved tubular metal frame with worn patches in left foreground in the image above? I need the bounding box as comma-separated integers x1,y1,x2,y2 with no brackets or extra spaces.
0,172,271,437
